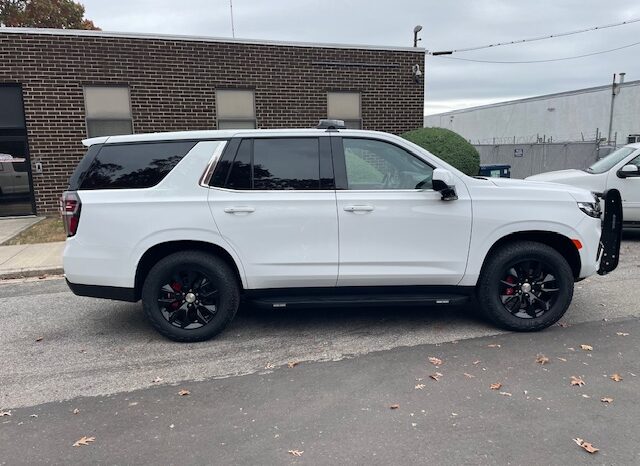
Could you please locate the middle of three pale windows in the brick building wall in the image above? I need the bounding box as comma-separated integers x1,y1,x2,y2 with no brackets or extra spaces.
216,89,256,129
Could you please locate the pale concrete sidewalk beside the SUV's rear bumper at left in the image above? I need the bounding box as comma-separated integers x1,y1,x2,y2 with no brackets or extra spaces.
0,241,64,280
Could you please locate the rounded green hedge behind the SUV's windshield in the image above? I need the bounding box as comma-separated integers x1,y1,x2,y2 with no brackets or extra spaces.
402,128,480,176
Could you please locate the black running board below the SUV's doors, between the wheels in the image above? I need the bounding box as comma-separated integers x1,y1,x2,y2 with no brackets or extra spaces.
248,294,469,309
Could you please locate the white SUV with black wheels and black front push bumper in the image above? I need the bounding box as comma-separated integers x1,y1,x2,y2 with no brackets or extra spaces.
62,123,621,341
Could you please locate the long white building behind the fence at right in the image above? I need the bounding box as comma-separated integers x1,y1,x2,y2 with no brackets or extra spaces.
425,76,640,145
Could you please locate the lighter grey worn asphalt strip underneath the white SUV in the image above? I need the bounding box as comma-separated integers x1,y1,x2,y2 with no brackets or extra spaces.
0,232,640,409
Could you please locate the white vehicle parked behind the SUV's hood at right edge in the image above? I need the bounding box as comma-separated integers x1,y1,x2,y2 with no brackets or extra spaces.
526,144,640,227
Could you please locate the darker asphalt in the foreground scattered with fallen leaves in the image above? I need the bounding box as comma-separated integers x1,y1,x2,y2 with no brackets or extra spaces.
0,318,640,465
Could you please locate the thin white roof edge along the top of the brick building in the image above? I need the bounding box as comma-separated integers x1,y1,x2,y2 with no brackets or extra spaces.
0,27,425,53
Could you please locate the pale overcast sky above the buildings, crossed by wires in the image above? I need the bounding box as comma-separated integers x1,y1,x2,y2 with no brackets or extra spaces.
81,0,640,113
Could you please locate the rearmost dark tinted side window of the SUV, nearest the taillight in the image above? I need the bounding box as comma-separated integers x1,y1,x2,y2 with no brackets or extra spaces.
80,141,197,189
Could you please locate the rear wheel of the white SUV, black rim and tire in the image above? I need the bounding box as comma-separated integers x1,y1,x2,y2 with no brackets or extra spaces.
142,251,240,342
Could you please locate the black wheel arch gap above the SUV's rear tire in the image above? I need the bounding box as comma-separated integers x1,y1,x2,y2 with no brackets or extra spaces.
134,240,244,299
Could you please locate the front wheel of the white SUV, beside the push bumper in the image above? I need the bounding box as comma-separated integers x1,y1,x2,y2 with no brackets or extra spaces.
476,241,574,332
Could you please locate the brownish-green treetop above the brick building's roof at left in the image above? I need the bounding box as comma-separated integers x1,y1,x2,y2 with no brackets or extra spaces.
0,0,100,30
